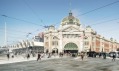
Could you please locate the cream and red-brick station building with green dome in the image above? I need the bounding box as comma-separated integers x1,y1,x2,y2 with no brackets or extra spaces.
44,12,119,52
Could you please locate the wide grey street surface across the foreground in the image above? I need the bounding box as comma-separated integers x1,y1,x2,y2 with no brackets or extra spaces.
0,57,119,71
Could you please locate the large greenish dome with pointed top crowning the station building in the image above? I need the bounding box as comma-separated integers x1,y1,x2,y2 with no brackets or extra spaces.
61,12,80,26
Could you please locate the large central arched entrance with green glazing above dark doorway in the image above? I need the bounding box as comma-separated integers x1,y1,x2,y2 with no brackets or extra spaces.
64,42,78,53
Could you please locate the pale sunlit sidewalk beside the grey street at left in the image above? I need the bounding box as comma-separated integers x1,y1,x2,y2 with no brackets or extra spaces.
0,56,59,64
